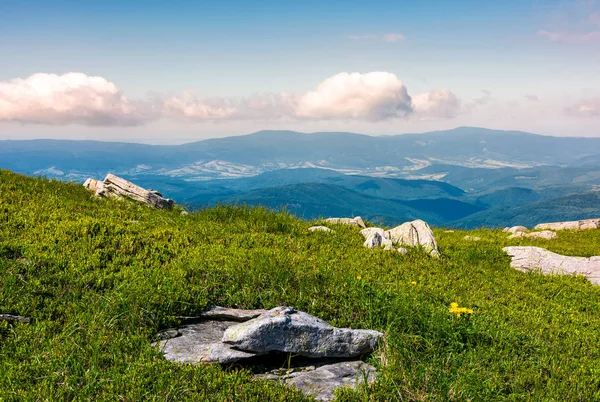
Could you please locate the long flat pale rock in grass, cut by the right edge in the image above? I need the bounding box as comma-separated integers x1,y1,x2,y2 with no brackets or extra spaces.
503,246,600,285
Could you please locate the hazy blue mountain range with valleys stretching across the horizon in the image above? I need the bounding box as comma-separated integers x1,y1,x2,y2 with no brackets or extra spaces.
0,127,600,228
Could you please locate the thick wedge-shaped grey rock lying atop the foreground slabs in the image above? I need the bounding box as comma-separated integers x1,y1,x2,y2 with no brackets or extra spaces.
223,307,383,357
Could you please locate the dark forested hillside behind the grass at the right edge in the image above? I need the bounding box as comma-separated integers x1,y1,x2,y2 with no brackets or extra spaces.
452,191,600,229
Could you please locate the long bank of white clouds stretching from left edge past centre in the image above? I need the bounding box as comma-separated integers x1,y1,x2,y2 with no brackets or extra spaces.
0,71,460,126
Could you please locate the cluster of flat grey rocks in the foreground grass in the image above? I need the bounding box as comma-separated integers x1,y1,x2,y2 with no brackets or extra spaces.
157,307,383,401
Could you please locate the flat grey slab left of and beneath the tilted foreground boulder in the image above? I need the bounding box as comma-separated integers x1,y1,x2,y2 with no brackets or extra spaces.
158,320,257,364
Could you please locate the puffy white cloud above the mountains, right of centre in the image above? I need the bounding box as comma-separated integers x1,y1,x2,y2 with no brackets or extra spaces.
296,71,412,121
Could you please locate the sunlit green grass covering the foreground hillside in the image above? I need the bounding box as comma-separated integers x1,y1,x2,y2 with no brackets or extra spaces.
0,171,600,401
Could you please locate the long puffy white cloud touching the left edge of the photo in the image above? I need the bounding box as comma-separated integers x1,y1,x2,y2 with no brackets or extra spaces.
0,73,148,126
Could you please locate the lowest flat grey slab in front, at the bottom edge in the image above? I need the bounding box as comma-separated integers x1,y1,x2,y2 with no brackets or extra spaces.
255,360,376,401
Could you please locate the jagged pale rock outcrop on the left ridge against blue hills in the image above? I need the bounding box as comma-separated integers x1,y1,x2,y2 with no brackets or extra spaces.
83,173,174,209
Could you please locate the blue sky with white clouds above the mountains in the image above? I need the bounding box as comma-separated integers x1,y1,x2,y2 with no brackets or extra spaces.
0,0,600,144
